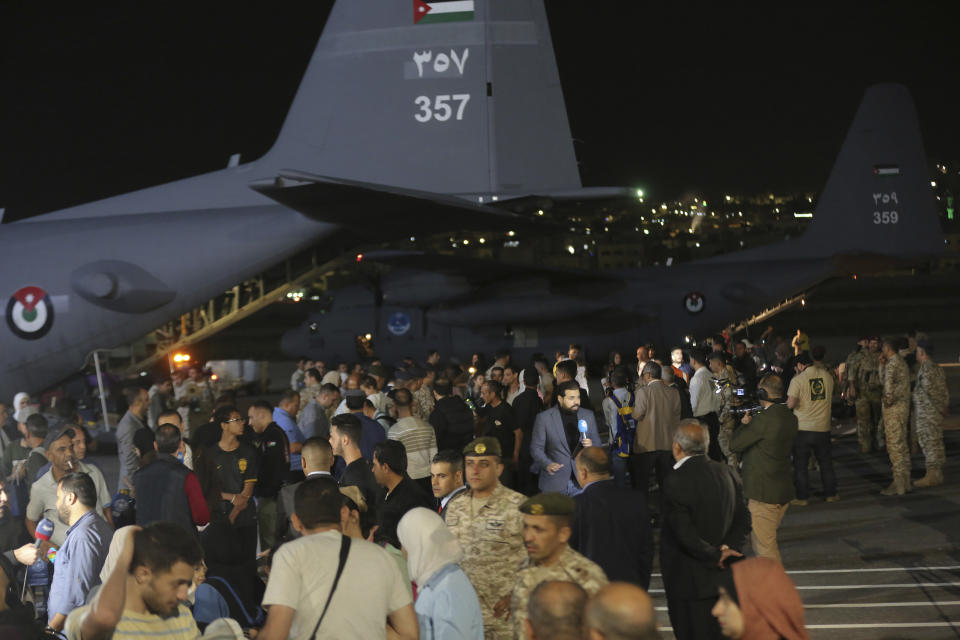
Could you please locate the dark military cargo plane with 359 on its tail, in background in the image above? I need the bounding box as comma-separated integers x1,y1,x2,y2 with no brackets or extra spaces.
282,84,944,362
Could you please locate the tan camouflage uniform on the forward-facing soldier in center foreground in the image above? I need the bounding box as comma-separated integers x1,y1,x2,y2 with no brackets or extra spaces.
446,484,527,640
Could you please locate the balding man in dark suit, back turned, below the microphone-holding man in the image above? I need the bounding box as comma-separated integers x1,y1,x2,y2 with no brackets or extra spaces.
570,447,653,589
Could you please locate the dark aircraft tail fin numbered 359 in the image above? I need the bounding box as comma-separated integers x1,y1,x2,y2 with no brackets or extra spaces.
801,84,943,257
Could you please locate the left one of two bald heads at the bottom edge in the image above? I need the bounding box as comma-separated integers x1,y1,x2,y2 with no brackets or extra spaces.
523,580,584,640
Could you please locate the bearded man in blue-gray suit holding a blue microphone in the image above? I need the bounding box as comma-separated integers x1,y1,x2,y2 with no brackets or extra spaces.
530,380,600,495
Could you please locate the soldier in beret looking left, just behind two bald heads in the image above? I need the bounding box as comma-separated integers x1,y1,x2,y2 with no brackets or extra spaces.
510,493,608,638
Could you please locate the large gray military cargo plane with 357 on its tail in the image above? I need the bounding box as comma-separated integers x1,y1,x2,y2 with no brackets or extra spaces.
0,0,632,398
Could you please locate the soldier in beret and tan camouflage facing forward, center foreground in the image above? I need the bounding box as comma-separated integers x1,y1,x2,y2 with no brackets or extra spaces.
446,437,527,640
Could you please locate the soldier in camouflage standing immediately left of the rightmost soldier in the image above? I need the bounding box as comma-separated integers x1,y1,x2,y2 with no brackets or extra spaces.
881,338,910,496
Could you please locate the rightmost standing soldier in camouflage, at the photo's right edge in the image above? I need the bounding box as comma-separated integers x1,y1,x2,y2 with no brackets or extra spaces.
913,340,950,487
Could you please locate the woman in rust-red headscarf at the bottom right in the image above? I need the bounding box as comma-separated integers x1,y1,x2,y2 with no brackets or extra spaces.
711,558,810,640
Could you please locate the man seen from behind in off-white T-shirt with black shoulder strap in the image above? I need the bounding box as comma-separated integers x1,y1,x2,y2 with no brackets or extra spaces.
258,478,418,640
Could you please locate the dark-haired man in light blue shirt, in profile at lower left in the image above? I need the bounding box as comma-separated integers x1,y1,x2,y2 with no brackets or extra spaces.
47,473,113,631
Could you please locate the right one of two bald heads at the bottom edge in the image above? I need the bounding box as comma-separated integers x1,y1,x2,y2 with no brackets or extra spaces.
583,582,660,640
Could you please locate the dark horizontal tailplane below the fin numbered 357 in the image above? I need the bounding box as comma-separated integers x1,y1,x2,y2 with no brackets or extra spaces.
250,171,559,234
